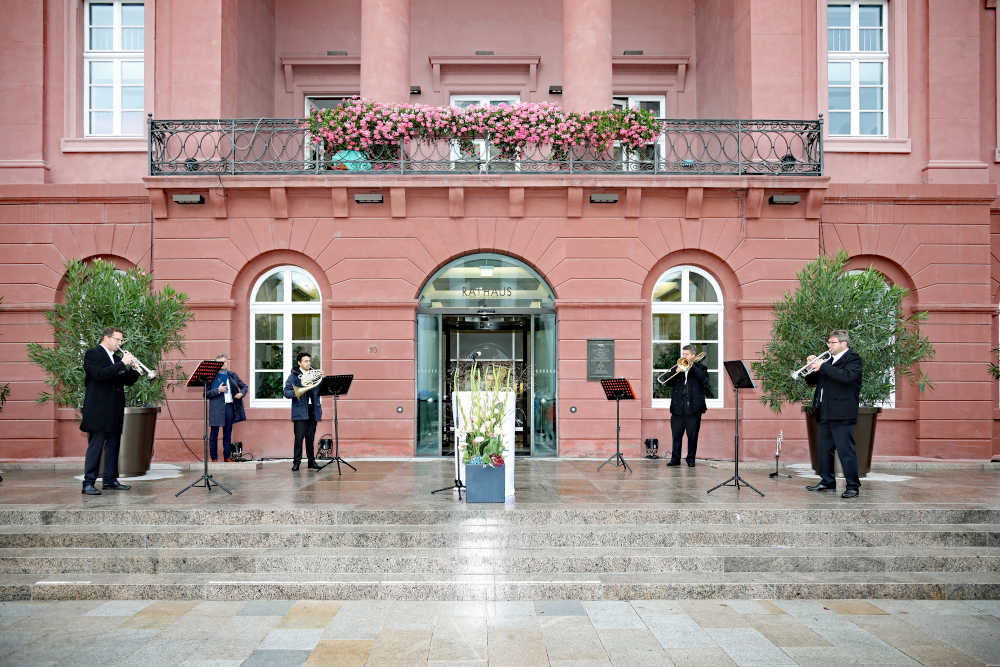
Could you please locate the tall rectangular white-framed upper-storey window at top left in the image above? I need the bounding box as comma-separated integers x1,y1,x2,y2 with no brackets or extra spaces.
83,0,145,137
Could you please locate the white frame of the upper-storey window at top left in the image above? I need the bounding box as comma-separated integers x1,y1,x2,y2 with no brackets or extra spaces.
81,0,149,139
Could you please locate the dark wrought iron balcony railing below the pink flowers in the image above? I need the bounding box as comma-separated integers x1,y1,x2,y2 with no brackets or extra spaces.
149,117,823,176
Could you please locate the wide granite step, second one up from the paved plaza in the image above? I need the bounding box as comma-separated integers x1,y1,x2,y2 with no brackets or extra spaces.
0,546,1000,575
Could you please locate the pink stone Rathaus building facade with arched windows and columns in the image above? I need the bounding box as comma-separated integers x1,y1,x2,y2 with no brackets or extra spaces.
0,0,1000,460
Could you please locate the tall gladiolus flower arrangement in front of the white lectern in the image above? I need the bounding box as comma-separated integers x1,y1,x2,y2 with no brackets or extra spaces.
453,362,514,468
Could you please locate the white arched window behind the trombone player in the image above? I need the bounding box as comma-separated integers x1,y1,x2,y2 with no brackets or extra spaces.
652,266,723,408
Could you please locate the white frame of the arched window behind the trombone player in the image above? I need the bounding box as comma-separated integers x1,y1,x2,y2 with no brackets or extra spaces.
649,264,726,409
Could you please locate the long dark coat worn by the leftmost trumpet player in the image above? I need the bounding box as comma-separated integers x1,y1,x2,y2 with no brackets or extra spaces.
80,345,139,433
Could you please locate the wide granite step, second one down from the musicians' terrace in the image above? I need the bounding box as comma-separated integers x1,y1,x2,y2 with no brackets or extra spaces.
0,523,1000,549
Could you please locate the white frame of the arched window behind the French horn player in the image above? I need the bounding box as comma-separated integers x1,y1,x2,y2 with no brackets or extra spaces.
247,264,324,408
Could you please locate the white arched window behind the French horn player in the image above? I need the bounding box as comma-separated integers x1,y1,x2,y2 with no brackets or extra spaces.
250,266,323,406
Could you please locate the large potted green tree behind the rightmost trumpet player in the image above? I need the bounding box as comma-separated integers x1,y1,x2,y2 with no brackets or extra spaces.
751,250,934,475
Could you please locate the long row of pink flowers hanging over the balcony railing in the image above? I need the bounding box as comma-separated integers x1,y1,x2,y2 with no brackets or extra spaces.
303,98,662,160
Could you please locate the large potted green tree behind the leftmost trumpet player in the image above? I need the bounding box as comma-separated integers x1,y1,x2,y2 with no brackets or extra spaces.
28,259,193,475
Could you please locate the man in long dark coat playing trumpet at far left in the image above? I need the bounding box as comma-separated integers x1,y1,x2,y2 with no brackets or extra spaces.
80,327,139,496
